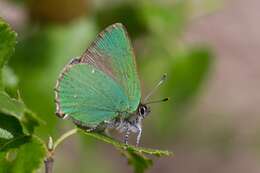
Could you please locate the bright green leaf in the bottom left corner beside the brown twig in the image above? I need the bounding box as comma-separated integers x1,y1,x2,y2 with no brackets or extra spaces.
0,136,47,173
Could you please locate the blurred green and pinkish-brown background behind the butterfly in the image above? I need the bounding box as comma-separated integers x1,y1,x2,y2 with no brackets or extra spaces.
0,0,260,173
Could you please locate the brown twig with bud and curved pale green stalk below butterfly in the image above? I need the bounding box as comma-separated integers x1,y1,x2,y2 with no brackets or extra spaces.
44,128,78,173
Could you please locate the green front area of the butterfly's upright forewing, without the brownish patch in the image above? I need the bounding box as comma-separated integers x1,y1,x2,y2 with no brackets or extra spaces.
97,25,141,111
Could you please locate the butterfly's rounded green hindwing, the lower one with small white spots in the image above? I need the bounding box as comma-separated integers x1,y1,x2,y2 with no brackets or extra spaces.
59,64,129,126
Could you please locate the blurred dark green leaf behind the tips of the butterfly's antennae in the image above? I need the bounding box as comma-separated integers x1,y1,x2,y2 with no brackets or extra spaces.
166,48,212,110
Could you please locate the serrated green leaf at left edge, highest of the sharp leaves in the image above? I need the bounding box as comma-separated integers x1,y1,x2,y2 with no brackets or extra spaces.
0,18,16,89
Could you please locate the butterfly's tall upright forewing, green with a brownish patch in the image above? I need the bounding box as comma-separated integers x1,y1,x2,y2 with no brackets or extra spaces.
80,23,141,112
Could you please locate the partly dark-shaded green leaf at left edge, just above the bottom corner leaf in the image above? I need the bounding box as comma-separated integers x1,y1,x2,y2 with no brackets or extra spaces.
0,99,40,152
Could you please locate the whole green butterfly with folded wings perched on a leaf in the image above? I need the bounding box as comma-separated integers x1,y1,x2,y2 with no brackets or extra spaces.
54,23,168,145
